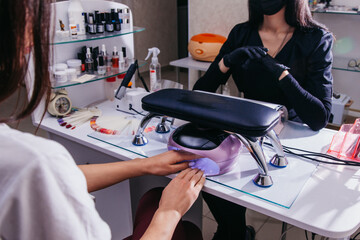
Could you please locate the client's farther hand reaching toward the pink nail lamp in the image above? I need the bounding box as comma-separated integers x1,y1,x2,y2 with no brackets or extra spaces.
142,150,200,176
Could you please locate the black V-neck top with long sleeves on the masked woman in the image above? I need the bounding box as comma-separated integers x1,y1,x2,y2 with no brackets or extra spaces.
194,22,333,131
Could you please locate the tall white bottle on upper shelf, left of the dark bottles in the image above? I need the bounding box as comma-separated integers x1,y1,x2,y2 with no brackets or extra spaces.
68,0,86,35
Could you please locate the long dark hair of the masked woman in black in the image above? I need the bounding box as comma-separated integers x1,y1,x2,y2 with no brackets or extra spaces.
248,0,327,30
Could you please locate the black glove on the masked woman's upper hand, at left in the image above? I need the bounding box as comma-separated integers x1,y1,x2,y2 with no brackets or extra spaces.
223,47,266,68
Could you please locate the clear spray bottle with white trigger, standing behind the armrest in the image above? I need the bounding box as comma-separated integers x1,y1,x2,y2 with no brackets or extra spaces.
145,47,161,92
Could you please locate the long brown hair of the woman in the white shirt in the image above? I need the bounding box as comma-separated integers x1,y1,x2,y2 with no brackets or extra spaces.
0,0,51,123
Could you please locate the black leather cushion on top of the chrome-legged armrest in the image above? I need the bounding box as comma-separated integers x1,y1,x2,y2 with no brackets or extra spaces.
142,89,279,137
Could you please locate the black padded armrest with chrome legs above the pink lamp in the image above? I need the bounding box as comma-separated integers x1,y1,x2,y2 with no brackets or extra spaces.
133,89,287,187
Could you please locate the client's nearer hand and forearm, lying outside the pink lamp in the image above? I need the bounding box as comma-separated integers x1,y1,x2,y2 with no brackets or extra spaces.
141,168,205,240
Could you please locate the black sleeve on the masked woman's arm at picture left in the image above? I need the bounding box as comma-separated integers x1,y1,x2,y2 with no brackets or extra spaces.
193,25,238,92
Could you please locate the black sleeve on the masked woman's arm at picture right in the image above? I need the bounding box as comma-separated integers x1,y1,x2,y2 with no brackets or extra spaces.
279,33,333,131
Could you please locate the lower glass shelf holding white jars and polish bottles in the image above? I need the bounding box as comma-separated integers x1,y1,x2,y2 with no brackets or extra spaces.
51,59,147,89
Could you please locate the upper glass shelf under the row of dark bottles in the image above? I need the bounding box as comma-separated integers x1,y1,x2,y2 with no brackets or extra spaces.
51,27,145,45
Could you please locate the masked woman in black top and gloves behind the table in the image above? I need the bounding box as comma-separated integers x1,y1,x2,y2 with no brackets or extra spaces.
194,0,333,240
